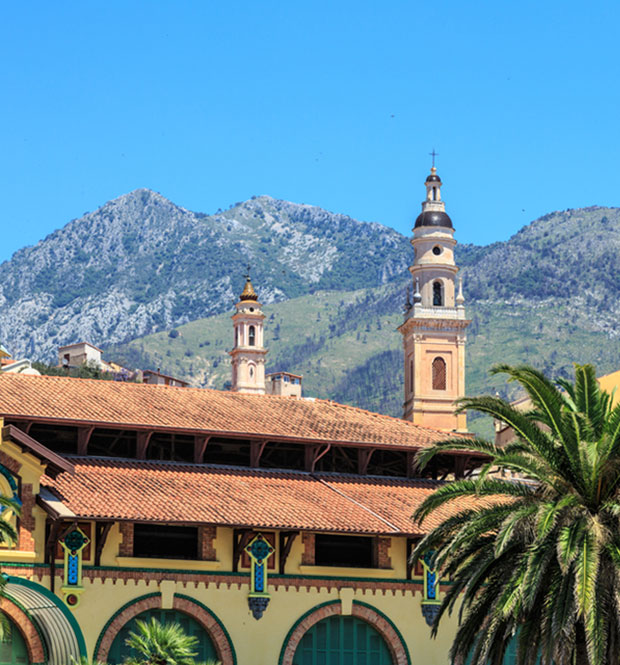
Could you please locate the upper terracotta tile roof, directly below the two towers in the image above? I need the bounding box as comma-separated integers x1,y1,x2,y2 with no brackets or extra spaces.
0,374,464,448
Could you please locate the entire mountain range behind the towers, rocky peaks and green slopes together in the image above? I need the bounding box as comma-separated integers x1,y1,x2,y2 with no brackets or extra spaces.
0,190,620,438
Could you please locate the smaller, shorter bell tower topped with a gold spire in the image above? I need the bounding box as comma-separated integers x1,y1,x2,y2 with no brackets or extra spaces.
229,274,267,395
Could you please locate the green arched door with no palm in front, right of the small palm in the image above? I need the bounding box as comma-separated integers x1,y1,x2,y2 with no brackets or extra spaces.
293,616,394,665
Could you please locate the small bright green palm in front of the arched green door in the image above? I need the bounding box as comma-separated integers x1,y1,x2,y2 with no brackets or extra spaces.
125,617,218,665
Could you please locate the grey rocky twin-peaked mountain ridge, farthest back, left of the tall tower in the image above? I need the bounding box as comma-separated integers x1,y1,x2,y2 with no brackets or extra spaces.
0,189,407,360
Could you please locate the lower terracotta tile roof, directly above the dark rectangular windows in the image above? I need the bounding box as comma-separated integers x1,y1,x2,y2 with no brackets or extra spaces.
43,457,450,535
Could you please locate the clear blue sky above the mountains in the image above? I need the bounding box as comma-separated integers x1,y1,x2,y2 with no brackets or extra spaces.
0,0,620,260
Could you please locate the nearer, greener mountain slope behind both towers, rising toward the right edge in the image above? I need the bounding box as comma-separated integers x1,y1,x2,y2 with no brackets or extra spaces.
110,207,620,434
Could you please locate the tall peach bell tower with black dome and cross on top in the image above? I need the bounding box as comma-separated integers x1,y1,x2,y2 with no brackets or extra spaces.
399,163,470,431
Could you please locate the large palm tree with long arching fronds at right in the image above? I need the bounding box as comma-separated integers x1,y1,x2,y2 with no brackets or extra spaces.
413,365,620,665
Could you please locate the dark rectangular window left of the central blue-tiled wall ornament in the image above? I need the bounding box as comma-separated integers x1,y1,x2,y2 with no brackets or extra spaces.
133,524,198,559
